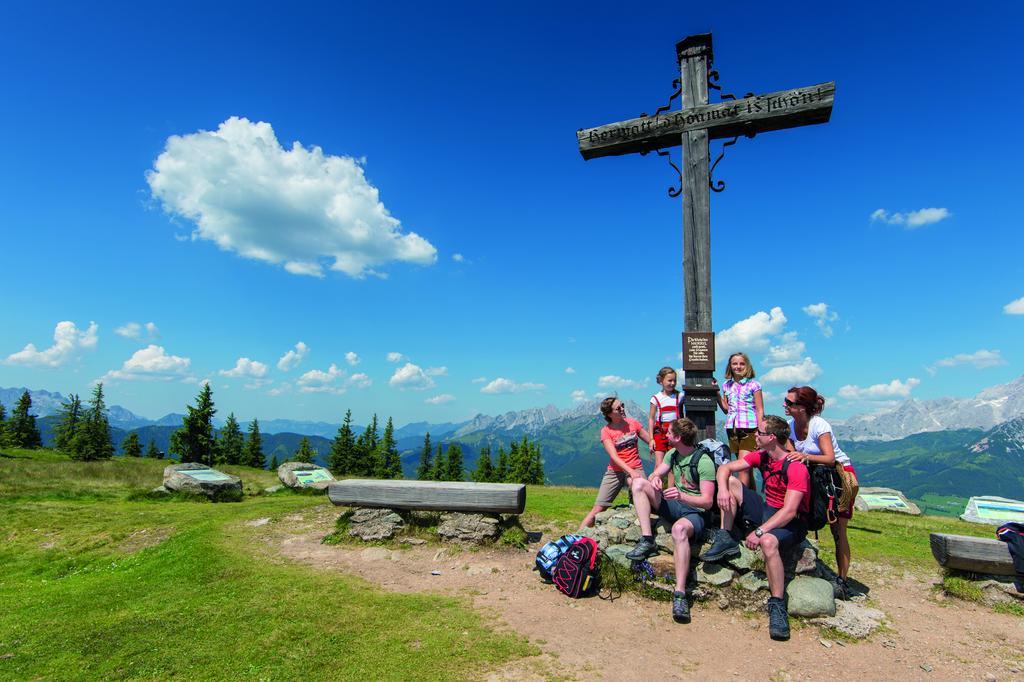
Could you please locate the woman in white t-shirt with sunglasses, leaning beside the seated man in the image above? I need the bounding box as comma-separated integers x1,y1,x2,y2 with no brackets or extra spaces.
783,386,857,599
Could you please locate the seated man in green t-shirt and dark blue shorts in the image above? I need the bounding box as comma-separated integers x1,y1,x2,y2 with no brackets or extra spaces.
626,419,716,623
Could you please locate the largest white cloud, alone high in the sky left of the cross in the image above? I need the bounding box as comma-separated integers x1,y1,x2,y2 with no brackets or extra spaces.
145,117,437,278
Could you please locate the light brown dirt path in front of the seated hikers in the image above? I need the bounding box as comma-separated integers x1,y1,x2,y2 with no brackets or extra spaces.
267,509,1024,682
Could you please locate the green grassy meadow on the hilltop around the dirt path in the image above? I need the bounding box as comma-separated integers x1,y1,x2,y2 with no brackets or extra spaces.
0,450,1007,680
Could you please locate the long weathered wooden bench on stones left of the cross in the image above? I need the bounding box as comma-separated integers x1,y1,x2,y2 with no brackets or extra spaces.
328,478,526,514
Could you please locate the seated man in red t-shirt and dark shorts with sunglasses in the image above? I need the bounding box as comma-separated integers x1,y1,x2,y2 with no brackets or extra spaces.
702,415,810,641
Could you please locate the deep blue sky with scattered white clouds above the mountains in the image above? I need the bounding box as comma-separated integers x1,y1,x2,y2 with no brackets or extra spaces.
0,2,1024,424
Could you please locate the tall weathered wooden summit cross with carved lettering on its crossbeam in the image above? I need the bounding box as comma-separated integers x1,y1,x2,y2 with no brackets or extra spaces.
577,34,836,436
